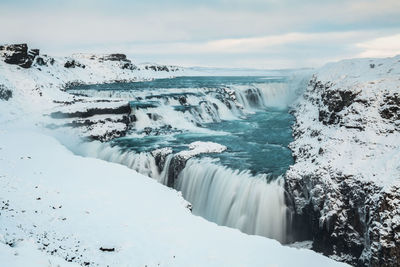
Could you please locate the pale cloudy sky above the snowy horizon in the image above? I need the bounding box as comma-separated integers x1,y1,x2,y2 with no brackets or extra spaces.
0,0,400,69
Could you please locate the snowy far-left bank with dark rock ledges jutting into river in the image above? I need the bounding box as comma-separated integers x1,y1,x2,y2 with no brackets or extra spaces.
0,44,185,140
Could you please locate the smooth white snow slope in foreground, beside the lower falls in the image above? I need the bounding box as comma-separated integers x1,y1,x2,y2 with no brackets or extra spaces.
0,129,343,266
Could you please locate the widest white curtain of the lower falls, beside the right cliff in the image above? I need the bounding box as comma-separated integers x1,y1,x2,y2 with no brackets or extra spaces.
176,159,287,245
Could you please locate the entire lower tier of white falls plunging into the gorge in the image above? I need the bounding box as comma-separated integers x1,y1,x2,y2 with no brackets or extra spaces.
75,141,287,243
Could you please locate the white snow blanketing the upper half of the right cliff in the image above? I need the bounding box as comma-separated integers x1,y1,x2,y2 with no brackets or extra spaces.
291,56,400,191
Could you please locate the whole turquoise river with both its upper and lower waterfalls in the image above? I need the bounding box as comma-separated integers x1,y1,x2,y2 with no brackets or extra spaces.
69,77,302,245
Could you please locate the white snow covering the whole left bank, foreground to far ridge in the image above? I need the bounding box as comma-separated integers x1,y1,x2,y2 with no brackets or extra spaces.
0,45,344,267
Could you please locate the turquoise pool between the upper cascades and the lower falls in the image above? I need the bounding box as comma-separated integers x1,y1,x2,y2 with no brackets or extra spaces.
113,109,293,177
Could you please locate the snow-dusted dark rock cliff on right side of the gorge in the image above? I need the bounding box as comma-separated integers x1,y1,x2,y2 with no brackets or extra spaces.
285,57,400,266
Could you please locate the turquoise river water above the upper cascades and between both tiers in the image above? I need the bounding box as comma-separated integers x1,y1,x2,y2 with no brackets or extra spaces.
70,77,293,177
